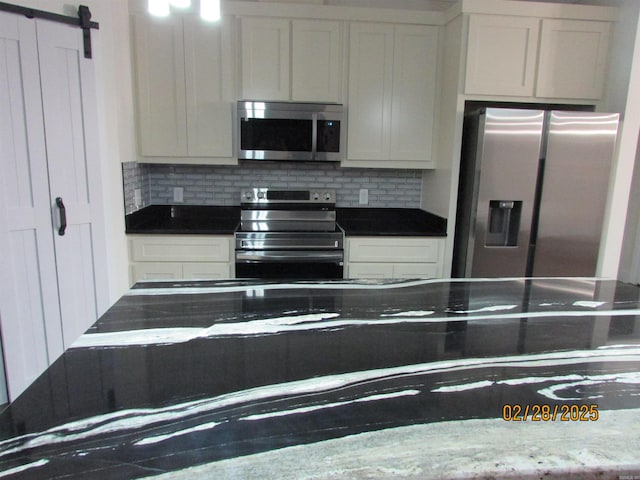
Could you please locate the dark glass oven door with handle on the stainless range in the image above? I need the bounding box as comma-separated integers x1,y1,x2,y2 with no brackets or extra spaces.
236,250,344,280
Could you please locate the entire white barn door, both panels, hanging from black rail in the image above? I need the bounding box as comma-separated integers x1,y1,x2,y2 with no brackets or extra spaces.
0,13,107,401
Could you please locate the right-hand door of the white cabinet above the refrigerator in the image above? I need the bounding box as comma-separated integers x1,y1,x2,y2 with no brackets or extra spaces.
536,20,611,99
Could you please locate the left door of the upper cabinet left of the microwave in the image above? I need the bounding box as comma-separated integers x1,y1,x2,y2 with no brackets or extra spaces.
133,15,187,157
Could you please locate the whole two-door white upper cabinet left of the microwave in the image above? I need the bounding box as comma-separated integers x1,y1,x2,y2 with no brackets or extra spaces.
133,14,234,163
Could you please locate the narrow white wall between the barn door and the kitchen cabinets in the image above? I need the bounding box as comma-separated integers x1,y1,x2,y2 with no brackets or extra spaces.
11,0,135,303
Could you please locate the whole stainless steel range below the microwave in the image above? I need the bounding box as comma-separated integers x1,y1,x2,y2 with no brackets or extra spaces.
235,188,344,279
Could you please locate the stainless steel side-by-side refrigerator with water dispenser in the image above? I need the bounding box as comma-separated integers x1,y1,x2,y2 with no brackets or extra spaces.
453,108,619,277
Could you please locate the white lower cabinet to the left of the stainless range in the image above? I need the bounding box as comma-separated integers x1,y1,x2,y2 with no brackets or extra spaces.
129,235,235,284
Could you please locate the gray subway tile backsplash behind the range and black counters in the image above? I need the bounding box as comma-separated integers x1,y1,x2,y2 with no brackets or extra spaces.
123,162,422,213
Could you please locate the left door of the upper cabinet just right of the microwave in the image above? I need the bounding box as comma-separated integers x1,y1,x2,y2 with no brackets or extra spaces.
347,23,394,160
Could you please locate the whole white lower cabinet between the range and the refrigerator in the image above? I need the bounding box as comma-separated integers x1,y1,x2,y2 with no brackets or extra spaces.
345,237,444,278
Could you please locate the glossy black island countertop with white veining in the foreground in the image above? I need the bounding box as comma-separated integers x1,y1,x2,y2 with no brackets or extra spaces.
0,278,640,480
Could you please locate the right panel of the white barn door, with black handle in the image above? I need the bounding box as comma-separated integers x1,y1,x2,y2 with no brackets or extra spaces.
36,20,107,357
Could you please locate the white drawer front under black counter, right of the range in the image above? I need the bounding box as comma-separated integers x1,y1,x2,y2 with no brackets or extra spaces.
348,237,442,263
